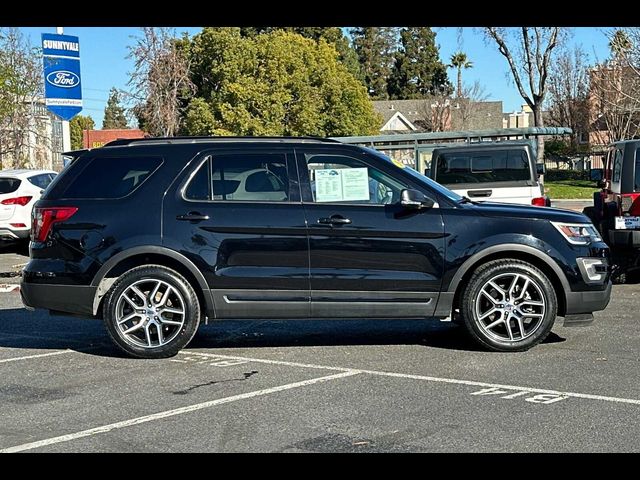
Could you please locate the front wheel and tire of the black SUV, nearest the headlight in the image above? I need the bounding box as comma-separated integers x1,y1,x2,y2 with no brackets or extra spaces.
460,259,558,352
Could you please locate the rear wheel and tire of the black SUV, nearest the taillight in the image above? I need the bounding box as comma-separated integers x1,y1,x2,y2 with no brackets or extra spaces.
102,265,201,358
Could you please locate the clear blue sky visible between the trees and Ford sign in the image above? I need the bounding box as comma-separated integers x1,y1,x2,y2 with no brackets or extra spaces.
21,27,608,128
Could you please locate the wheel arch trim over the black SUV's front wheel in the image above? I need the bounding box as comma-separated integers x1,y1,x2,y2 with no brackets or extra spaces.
448,244,571,316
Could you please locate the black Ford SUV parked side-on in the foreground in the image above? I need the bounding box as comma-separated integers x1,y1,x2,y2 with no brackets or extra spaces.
21,138,611,358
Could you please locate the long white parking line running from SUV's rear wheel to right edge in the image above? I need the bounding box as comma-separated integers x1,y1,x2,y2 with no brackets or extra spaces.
186,352,640,405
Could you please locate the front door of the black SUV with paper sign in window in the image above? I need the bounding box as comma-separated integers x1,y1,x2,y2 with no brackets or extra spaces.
296,146,444,318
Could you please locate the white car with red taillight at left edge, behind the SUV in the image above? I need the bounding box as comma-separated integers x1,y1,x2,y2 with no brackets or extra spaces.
0,170,57,243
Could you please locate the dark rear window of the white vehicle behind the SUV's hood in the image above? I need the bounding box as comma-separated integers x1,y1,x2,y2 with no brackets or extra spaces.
436,150,531,185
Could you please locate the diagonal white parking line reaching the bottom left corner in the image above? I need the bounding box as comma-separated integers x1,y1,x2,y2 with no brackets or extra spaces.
0,370,360,453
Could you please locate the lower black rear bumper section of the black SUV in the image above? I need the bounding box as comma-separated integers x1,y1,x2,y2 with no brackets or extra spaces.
20,280,97,317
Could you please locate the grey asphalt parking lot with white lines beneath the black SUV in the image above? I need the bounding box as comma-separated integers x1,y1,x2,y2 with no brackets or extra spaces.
0,242,640,452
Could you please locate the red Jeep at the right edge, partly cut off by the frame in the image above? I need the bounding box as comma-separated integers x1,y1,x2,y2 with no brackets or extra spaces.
583,140,640,283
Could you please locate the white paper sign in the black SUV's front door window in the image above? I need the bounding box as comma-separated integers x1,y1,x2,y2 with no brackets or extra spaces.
315,167,369,202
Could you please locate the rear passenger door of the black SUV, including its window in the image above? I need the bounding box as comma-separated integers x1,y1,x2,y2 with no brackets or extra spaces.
163,146,310,318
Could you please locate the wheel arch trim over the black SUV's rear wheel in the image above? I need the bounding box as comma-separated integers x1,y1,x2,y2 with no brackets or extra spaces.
91,245,213,317
